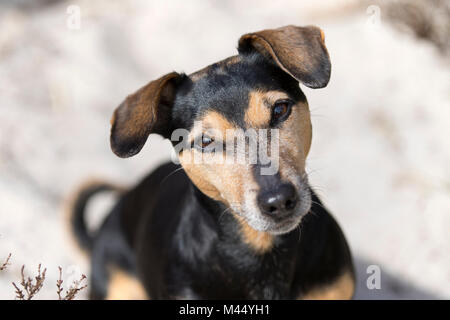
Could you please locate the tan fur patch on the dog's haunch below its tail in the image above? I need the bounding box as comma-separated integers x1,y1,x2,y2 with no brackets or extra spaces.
106,269,148,300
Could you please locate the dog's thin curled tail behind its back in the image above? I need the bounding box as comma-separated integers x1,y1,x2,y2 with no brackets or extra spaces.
68,181,124,251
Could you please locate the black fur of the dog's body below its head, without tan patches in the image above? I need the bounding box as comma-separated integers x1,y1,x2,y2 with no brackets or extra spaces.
74,163,353,299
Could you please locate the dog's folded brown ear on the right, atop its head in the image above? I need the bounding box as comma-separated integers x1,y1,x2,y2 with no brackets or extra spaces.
238,26,331,88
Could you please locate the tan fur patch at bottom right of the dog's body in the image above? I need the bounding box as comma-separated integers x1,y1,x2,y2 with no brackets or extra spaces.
301,271,355,300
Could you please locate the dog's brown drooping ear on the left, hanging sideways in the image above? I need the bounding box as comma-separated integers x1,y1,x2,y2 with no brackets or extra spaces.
110,72,183,158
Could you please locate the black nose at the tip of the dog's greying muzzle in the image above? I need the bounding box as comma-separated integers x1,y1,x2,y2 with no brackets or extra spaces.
257,183,297,218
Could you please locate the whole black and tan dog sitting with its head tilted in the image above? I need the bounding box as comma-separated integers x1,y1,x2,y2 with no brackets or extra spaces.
72,26,354,299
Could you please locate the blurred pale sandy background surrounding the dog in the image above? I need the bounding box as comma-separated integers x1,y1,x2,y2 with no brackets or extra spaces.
0,0,450,299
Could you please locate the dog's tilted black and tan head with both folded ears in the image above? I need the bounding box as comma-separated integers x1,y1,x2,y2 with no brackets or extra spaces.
111,26,331,234
